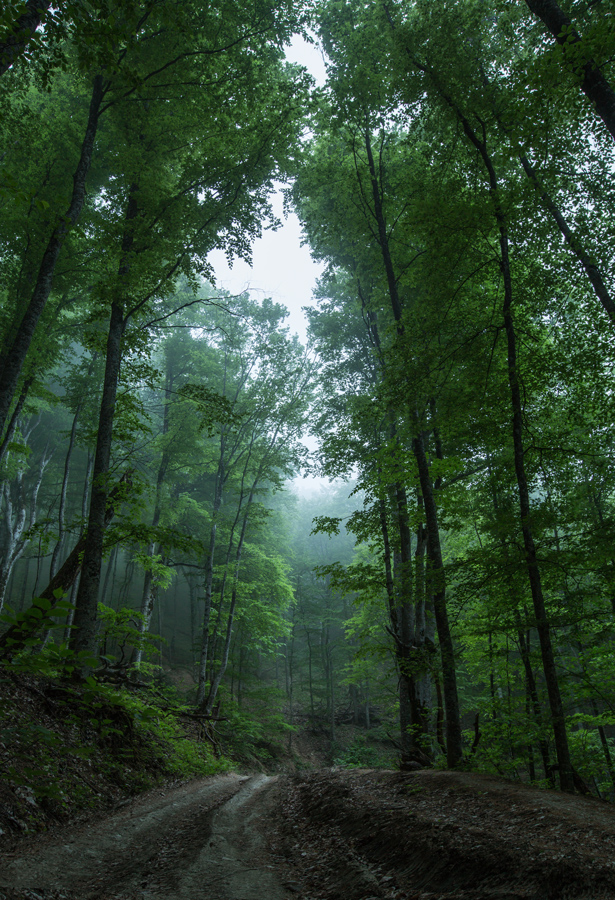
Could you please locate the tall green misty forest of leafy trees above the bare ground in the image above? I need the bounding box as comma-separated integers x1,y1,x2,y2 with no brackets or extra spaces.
0,0,615,798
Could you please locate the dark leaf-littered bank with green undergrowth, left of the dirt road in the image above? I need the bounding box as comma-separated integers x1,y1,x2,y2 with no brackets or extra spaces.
0,600,231,839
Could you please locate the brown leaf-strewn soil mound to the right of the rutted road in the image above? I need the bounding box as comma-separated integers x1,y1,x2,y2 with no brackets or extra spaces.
280,770,615,900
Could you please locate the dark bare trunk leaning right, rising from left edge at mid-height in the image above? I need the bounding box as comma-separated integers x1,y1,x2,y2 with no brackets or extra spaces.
0,75,104,434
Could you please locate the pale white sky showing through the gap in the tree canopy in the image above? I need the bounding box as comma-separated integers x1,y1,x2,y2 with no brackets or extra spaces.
209,36,325,343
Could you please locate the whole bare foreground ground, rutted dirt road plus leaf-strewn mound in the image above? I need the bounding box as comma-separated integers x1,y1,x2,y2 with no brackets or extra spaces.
0,769,615,900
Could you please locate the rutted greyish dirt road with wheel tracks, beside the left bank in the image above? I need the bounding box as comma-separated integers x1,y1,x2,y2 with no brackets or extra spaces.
0,775,296,900
